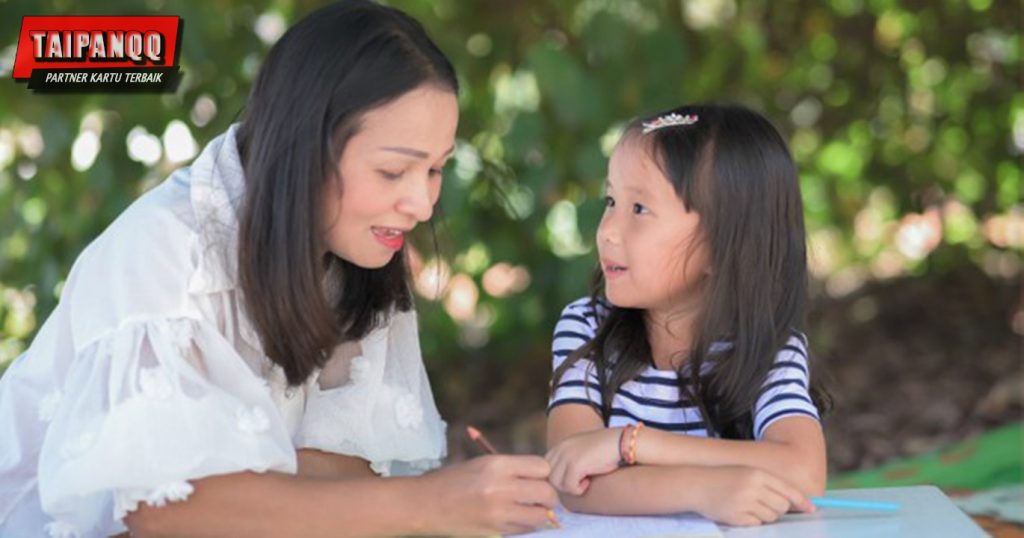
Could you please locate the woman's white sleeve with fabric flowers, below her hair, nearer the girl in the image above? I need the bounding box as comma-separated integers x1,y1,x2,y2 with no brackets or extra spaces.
296,312,446,475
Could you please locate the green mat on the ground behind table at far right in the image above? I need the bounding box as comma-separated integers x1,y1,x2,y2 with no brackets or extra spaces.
828,422,1024,491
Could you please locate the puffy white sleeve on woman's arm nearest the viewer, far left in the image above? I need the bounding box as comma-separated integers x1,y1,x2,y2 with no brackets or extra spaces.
39,318,296,536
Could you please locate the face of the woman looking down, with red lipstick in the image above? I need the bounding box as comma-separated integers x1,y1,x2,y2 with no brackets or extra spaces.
323,85,459,268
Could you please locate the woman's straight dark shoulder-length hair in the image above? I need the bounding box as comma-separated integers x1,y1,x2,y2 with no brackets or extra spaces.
238,0,458,384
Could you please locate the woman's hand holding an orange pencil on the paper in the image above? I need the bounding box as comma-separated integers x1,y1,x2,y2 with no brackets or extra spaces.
422,456,558,535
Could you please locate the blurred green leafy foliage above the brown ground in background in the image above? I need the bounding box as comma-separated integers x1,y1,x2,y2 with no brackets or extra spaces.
0,0,1024,405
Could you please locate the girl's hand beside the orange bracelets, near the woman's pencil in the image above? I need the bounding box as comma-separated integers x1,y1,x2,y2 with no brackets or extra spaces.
545,427,623,495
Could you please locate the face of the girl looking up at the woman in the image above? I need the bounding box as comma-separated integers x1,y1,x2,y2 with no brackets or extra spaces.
597,134,710,312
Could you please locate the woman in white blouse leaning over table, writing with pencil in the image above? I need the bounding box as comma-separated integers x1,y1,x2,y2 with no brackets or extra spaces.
0,0,556,537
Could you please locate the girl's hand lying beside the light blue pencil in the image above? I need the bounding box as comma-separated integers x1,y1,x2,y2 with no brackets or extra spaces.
689,466,814,527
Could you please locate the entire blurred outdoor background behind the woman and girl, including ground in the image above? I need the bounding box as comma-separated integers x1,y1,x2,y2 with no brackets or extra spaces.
0,0,1024,528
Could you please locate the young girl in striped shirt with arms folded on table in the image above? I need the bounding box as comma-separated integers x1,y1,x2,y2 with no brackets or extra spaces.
547,106,828,525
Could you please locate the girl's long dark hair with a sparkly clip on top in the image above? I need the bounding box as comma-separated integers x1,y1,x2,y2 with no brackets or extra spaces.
553,105,831,439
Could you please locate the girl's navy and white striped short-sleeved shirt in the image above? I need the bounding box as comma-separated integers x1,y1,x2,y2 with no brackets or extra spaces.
548,297,819,440
